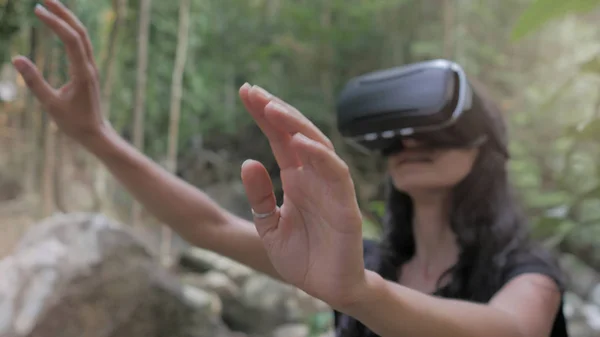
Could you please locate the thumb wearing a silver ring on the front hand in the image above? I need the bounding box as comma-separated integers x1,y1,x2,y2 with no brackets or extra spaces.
242,160,279,239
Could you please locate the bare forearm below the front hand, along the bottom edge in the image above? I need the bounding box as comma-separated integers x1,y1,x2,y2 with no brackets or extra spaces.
342,272,524,337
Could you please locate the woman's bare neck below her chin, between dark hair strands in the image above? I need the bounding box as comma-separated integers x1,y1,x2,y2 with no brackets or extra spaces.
413,190,458,274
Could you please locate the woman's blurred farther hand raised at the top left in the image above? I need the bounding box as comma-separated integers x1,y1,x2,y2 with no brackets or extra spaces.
13,0,108,143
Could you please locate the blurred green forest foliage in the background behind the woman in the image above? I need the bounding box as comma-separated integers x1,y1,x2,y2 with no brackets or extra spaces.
0,0,600,276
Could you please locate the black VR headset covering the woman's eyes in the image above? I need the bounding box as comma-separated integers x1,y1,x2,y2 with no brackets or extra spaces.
337,59,490,155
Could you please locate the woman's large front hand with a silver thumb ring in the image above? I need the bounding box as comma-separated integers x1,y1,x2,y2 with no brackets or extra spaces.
240,84,366,308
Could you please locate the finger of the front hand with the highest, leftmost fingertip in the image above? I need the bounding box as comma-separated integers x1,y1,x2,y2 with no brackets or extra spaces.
240,84,300,170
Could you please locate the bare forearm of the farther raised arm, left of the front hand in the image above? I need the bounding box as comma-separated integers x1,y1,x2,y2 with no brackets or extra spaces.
82,127,278,277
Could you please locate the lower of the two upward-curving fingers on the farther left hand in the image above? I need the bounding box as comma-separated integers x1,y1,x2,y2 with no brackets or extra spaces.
35,5,89,79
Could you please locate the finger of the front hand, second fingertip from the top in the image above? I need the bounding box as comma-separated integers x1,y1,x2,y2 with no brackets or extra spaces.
265,101,333,150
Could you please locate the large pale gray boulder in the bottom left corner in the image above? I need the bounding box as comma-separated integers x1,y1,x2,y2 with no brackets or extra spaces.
0,213,234,337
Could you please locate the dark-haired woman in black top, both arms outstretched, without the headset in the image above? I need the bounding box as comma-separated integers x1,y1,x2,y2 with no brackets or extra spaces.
13,0,566,337
